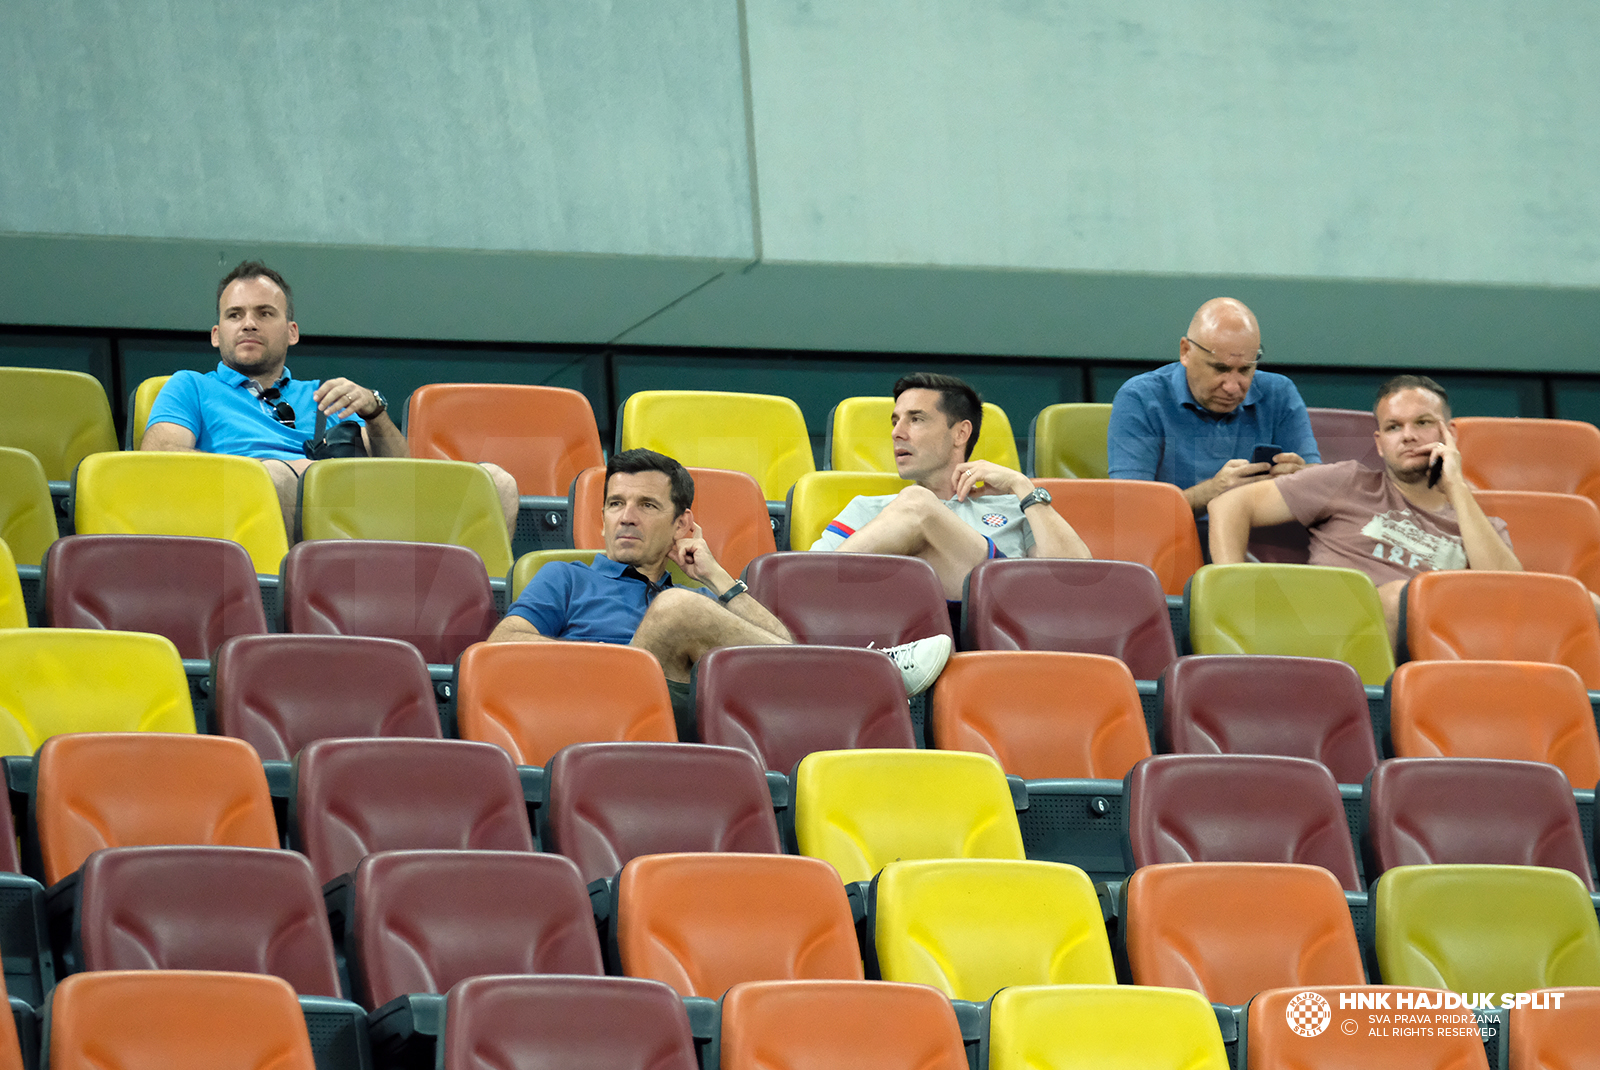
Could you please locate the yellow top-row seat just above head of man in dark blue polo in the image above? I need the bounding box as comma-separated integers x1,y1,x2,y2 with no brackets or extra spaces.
618,390,816,502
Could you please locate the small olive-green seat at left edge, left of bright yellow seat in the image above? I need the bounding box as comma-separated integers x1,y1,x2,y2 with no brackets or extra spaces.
0,368,117,480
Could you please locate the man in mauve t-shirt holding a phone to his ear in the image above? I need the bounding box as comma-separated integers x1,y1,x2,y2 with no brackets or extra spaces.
1210,376,1522,641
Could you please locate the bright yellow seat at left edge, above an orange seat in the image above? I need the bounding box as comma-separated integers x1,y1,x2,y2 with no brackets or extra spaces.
0,629,195,755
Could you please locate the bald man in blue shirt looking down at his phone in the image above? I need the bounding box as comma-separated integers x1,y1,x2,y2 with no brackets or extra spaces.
1106,297,1322,517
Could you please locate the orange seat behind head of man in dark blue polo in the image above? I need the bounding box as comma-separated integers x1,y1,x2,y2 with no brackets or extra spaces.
568,465,778,576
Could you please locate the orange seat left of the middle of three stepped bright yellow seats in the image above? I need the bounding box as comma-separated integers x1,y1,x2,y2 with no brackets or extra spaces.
616,854,862,1000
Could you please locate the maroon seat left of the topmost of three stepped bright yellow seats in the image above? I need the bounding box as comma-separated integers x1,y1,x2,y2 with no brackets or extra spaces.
539,744,782,884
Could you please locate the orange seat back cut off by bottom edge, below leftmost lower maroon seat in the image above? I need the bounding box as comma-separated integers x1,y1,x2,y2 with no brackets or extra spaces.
46,969,317,1070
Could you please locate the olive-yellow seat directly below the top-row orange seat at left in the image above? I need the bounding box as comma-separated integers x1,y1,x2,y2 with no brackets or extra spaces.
299,457,512,577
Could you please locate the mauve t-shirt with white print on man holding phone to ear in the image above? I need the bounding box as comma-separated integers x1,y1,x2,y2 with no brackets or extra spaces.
1274,461,1510,585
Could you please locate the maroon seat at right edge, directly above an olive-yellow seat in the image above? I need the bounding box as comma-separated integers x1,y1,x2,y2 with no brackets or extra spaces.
1362,758,1595,891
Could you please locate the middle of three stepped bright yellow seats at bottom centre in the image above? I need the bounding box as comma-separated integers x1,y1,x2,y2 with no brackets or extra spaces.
867,859,1117,1001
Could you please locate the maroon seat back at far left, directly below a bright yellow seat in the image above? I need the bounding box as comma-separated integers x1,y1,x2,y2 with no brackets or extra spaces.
45,534,267,657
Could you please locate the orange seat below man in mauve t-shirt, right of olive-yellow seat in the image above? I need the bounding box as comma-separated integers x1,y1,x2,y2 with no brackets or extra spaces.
1400,569,1600,691
